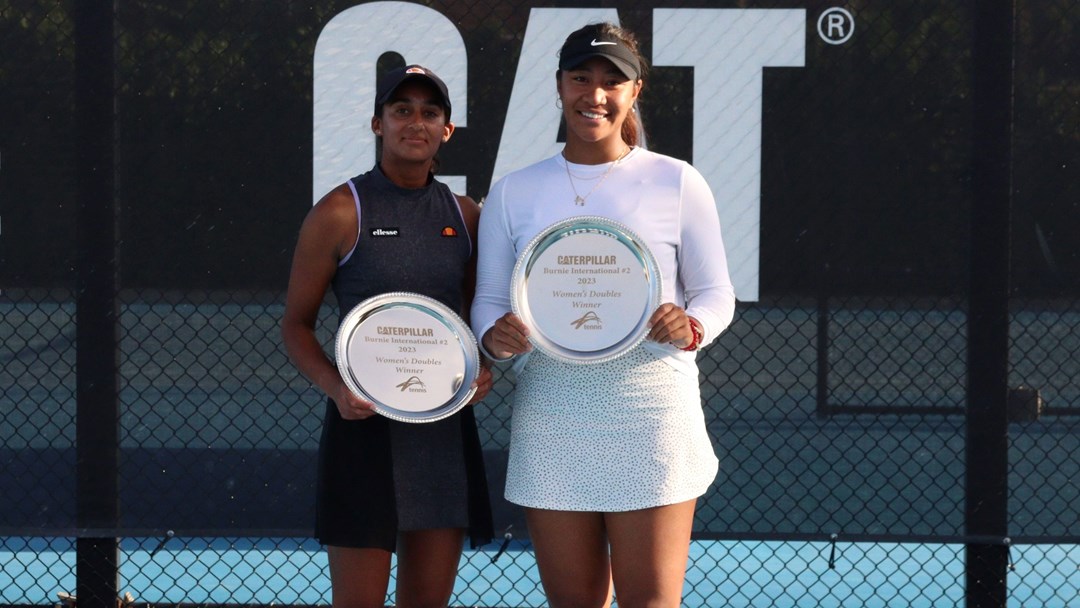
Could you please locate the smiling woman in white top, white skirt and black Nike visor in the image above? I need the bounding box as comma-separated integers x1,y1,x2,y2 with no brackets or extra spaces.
472,24,734,608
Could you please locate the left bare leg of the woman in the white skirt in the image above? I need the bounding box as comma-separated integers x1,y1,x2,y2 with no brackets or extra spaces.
525,509,611,608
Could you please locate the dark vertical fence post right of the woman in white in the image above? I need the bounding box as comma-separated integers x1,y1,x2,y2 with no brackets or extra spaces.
964,0,1015,607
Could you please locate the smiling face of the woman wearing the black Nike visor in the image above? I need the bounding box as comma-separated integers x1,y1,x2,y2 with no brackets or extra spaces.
557,57,642,147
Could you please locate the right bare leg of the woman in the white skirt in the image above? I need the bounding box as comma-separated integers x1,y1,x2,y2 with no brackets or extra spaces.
604,500,697,608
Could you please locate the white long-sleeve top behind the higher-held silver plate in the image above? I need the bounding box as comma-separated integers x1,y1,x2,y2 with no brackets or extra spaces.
471,148,735,375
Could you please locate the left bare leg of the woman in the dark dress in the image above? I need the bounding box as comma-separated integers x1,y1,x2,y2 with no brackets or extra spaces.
326,546,390,608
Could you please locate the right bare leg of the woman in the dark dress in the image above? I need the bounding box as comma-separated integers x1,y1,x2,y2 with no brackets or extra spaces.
396,528,465,608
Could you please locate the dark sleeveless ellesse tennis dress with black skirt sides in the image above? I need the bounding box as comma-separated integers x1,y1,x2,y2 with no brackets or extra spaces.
315,166,492,551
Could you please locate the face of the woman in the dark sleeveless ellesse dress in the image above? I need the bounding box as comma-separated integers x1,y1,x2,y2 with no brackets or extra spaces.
372,81,454,167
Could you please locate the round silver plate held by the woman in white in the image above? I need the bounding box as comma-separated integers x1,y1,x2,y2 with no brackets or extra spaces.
510,216,661,363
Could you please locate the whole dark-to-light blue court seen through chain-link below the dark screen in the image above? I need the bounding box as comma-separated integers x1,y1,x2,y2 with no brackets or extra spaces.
0,302,1080,608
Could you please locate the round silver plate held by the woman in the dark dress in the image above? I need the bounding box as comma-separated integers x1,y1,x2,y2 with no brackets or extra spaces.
334,292,480,422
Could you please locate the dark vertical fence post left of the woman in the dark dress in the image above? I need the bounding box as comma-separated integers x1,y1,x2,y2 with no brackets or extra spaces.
73,0,120,608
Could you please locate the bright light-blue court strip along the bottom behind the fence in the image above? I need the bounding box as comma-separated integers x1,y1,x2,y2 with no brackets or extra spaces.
0,539,1080,608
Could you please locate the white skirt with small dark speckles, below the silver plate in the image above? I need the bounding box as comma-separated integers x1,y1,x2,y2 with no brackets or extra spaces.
505,346,718,512
